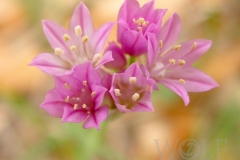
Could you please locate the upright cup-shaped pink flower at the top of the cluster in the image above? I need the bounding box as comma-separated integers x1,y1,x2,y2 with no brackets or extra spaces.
117,0,167,56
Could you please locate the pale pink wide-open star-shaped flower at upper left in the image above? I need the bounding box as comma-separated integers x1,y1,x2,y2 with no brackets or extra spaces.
30,3,113,76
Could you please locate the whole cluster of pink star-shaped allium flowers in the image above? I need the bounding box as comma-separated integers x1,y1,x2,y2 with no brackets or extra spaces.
30,0,218,129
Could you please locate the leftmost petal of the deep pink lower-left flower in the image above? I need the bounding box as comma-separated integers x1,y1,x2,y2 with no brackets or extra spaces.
40,88,66,118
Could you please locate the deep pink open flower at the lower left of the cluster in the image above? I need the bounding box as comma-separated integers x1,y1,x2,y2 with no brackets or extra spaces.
41,62,108,130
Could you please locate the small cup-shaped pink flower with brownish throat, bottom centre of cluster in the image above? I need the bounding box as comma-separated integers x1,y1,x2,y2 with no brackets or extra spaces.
109,63,153,113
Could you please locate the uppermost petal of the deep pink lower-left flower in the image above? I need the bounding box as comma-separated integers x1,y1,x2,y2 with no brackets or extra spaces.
73,62,102,85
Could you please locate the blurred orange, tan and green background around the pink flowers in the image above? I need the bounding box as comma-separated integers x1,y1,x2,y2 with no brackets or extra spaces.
0,0,240,160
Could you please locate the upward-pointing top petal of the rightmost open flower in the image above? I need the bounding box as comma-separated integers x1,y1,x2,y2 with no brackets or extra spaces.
157,13,181,52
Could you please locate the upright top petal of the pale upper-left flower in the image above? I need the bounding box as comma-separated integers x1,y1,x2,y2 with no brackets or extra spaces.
69,2,94,37
